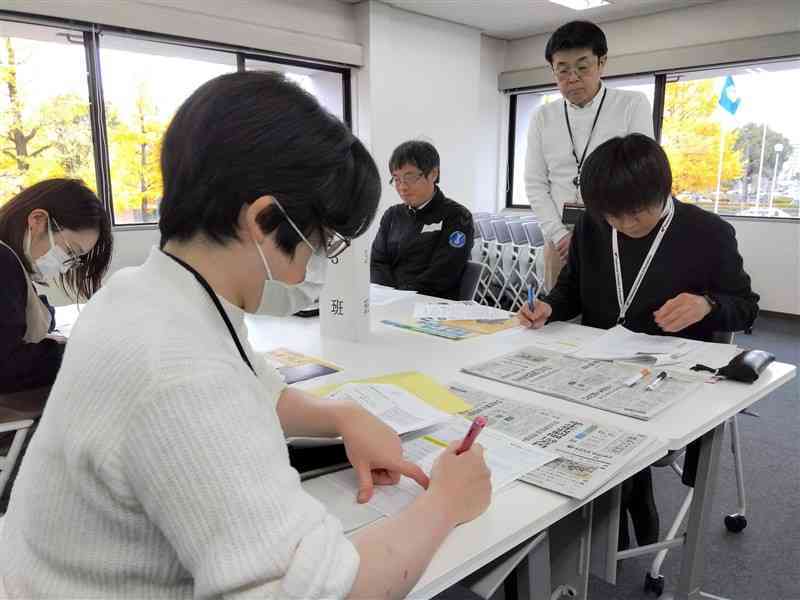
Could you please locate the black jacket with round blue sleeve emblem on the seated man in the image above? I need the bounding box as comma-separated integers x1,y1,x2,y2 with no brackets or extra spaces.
370,187,474,299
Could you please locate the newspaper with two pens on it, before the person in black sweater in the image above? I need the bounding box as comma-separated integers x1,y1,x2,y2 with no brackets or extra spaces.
462,347,702,421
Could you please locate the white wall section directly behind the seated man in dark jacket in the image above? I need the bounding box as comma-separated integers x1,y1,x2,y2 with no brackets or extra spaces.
357,1,505,223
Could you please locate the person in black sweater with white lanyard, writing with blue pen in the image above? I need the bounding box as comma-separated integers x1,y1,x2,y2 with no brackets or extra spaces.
520,134,759,547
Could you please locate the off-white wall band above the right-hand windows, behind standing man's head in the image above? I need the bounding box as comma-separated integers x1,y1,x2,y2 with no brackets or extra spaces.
504,0,800,71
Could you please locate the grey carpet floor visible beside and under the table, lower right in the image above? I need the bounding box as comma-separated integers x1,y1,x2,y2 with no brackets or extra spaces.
589,315,800,600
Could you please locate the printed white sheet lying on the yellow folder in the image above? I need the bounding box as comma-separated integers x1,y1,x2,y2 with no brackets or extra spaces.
328,383,451,434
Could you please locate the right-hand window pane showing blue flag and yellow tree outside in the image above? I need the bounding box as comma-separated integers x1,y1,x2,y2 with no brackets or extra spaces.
661,60,800,218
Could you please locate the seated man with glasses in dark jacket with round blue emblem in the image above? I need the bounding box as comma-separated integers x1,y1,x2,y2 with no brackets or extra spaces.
370,140,474,299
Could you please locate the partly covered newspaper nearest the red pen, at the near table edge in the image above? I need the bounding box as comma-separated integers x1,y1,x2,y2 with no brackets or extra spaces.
450,384,658,499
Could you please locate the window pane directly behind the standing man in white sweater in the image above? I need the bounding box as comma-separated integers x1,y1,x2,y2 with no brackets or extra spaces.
506,75,655,208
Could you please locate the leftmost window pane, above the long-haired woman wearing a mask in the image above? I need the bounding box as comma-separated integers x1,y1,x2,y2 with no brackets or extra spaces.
0,21,97,205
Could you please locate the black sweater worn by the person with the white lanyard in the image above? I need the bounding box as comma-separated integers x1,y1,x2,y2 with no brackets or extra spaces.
545,200,759,341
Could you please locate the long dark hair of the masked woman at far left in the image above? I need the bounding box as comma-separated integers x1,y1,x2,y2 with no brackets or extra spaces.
0,179,114,300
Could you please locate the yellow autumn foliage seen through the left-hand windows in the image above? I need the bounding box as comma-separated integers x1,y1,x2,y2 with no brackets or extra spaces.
0,38,167,221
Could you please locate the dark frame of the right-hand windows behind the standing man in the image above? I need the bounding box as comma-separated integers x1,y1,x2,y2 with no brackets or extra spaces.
505,54,800,223
